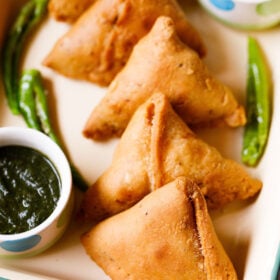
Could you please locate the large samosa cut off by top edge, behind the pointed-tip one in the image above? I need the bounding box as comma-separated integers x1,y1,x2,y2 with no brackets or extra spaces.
43,0,205,86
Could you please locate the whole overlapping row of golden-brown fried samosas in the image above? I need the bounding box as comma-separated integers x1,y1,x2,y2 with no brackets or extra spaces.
44,3,262,280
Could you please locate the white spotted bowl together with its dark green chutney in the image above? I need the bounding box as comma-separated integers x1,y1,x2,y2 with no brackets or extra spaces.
0,127,73,258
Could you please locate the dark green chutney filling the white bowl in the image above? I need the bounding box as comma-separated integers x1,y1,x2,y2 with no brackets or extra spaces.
0,145,61,234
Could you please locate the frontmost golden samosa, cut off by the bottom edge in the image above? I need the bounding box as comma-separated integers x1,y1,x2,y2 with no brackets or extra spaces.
82,177,237,280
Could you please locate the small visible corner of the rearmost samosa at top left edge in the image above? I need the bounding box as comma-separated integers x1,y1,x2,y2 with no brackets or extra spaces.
48,0,96,23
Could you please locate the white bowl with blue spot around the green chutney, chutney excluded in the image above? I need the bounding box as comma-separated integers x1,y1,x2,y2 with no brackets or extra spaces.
0,127,73,258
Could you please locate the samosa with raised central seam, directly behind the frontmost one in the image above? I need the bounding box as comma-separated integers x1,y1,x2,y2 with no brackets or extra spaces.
81,93,262,221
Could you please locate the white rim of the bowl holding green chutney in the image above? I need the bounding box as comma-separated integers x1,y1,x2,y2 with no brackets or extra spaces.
0,126,72,242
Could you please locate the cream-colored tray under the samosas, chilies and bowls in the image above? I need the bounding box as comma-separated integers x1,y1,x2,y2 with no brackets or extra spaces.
0,0,280,280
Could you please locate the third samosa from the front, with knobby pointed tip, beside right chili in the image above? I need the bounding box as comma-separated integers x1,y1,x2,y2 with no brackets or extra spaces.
83,17,246,140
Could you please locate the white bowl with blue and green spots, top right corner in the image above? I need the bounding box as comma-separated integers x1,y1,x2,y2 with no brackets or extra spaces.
199,0,280,30
